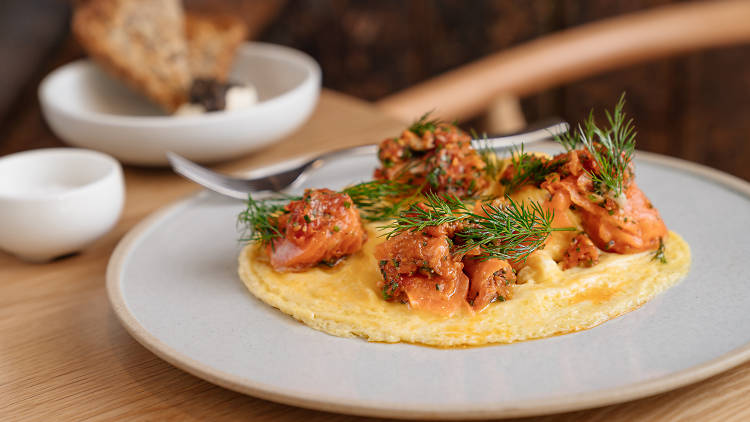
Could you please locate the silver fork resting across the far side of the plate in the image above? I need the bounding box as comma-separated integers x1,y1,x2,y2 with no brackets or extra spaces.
167,118,569,199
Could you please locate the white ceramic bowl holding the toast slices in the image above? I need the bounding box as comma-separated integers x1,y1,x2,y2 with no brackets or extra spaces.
39,42,320,165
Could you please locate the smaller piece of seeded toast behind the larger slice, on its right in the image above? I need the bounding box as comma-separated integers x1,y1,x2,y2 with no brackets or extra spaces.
185,12,247,82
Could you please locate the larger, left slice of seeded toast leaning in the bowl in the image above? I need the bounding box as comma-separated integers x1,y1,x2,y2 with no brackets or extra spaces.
72,0,192,112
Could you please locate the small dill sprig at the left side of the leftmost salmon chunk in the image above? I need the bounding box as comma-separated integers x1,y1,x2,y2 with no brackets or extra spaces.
237,195,300,246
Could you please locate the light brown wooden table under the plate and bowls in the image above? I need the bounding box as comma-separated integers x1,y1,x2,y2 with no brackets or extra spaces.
0,91,750,421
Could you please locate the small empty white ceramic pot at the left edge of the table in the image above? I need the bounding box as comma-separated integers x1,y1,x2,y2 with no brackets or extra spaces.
0,148,125,262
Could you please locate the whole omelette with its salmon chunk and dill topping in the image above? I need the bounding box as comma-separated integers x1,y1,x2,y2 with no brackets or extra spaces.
239,102,691,347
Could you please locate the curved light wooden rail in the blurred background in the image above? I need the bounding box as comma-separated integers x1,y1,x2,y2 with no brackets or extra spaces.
376,0,750,121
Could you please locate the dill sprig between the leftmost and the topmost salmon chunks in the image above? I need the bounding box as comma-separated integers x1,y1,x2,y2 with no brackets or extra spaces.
341,180,420,221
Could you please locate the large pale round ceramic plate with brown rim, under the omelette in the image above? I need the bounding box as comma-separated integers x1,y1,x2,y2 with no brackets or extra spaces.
107,148,750,418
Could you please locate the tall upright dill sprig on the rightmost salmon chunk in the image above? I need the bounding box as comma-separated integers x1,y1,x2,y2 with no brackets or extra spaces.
555,93,637,199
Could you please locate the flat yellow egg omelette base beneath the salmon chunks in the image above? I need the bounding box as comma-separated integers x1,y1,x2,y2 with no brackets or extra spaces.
239,223,690,347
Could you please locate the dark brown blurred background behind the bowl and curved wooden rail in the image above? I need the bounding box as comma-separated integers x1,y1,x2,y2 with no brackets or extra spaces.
0,0,750,180
